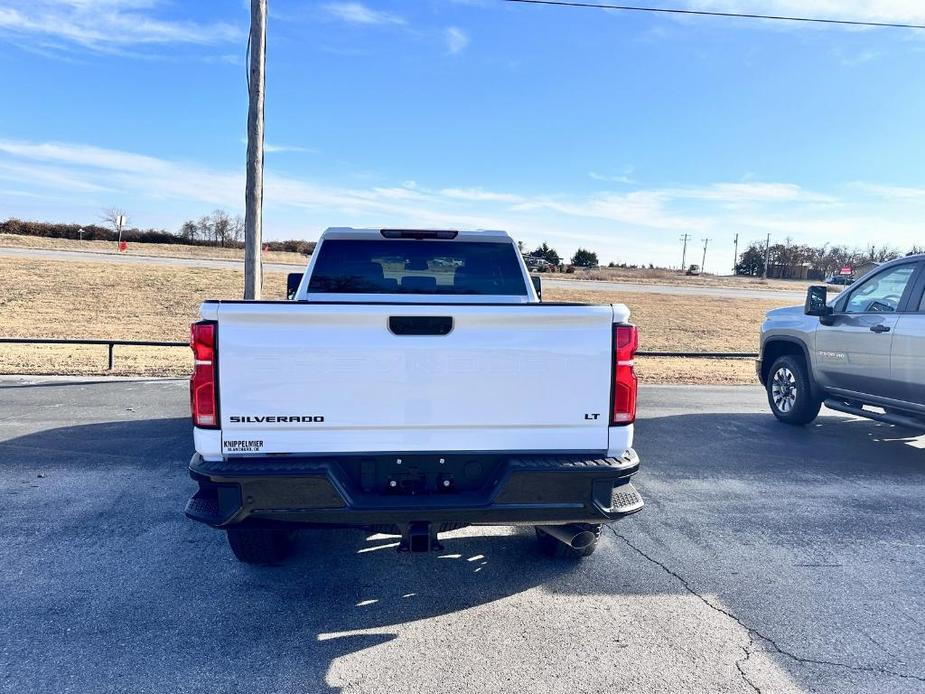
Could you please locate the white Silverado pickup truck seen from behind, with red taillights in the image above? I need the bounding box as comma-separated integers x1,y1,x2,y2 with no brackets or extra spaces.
186,229,642,564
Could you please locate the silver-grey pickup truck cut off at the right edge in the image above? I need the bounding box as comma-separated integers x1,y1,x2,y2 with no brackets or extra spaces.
757,255,925,428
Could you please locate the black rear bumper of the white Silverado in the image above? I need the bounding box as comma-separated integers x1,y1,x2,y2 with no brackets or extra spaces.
186,449,643,529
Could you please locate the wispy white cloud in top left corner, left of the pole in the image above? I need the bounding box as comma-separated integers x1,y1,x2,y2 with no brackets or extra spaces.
0,0,243,51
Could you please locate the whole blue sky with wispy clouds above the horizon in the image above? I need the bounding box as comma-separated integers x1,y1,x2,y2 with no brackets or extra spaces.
0,0,925,272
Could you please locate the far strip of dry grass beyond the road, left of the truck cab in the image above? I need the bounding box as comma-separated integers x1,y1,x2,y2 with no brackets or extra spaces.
0,234,305,266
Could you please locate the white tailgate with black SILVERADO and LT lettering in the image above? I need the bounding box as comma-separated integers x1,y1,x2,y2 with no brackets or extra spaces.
210,302,614,455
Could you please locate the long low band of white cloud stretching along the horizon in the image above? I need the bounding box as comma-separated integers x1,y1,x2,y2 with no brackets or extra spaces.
0,140,925,264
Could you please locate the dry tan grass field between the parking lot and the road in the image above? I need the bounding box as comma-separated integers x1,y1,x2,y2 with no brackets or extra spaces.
0,257,792,383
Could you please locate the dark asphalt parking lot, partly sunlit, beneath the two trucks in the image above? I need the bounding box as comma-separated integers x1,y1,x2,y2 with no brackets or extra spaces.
0,378,925,693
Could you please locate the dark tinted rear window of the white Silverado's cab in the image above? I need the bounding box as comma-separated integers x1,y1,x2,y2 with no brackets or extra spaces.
308,239,527,296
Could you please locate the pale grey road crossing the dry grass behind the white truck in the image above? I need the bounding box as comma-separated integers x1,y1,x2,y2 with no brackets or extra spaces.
0,247,805,304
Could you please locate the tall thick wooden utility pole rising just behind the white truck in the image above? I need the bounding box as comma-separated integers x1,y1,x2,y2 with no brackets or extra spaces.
244,0,267,299
